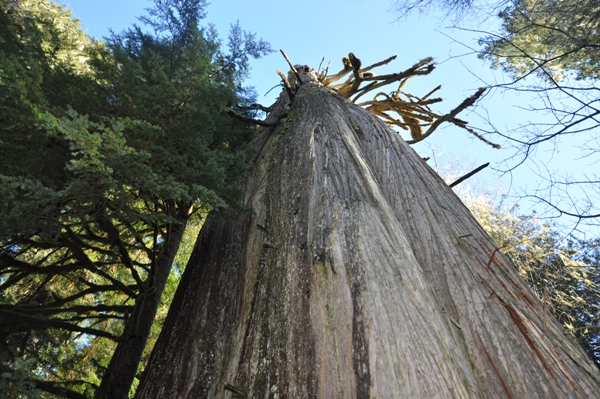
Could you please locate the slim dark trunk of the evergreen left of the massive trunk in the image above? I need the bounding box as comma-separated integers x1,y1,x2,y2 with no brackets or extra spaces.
95,216,187,399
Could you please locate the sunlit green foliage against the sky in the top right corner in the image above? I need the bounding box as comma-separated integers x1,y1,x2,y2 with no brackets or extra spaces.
480,0,600,81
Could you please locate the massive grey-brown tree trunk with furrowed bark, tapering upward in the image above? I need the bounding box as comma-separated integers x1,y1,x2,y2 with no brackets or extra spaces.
138,67,600,399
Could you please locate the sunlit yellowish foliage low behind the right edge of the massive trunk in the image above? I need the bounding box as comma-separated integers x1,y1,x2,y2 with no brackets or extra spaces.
467,198,600,367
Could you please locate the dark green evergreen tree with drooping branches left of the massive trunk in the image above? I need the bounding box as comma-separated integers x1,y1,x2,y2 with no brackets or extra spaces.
0,0,269,397
